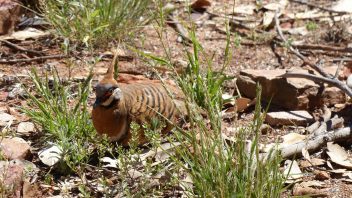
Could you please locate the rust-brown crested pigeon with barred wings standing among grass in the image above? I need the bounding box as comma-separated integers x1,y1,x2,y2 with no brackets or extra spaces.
92,55,187,146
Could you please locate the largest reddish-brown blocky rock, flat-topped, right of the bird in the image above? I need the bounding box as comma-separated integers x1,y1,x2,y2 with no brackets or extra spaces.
237,69,346,110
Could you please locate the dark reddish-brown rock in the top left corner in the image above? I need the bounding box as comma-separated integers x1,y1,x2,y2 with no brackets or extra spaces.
0,0,22,35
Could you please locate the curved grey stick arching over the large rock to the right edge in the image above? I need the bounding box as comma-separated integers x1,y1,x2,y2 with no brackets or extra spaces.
281,72,352,97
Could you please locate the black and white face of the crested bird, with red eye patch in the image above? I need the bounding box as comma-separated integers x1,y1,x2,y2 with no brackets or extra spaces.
94,84,122,107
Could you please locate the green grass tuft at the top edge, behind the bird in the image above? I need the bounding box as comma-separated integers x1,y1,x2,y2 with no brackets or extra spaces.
44,0,153,46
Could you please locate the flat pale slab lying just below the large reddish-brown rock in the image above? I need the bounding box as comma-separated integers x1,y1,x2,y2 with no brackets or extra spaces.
265,111,313,126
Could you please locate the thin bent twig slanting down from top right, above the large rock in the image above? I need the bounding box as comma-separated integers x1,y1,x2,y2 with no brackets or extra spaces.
275,11,331,77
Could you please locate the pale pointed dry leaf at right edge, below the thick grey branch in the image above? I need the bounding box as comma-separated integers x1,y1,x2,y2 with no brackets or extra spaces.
327,142,352,169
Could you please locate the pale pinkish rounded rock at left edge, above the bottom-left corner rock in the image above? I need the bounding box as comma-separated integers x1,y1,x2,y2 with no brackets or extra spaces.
0,137,30,160
